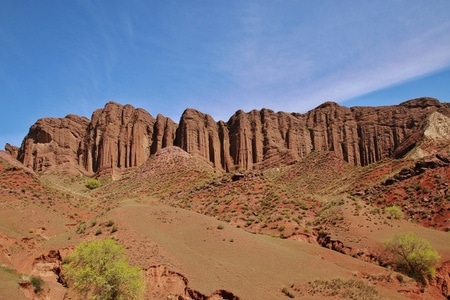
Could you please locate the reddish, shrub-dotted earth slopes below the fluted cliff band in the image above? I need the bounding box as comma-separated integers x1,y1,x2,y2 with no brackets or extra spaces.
0,152,450,299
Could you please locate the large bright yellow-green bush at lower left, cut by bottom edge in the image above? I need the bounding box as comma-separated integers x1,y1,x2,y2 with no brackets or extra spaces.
63,239,145,300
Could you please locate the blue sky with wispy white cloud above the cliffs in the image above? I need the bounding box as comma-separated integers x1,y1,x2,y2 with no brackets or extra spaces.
0,0,450,147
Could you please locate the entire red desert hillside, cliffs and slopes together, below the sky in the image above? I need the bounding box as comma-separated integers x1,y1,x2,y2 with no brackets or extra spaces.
0,98,450,300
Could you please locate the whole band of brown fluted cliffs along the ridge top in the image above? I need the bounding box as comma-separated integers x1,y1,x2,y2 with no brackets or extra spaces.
18,98,450,174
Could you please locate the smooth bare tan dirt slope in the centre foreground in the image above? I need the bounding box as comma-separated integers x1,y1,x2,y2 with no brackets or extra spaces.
109,203,414,299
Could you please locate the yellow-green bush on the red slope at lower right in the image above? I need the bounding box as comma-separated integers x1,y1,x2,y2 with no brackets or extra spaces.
385,232,440,283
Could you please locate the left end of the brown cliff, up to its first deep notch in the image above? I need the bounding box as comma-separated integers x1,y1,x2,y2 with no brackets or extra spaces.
18,102,177,174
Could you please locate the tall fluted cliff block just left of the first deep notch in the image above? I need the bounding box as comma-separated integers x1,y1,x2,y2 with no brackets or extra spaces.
79,102,176,172
